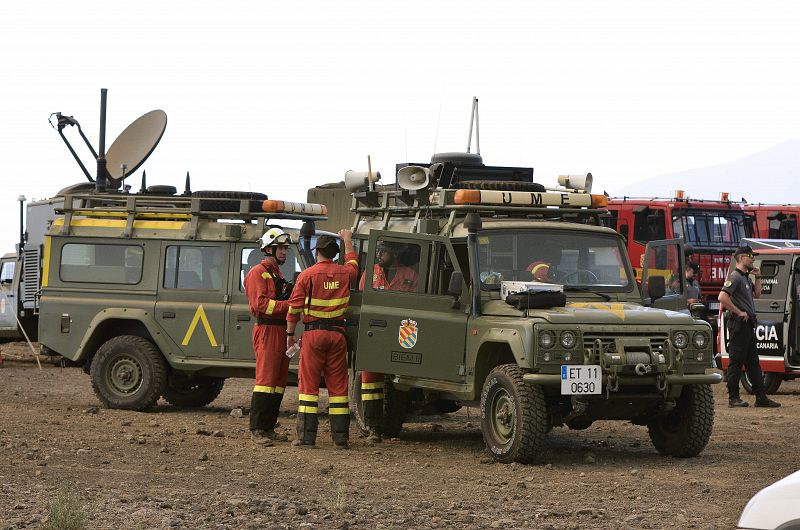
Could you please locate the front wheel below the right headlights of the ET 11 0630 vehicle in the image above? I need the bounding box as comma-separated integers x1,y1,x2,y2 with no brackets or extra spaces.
647,385,714,458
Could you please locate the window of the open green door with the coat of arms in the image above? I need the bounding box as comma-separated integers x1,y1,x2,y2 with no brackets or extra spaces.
359,239,425,293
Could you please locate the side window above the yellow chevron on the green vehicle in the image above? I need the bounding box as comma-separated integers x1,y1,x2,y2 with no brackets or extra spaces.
164,245,224,290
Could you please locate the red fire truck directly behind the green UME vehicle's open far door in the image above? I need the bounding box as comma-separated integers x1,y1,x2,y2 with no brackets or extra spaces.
608,190,749,348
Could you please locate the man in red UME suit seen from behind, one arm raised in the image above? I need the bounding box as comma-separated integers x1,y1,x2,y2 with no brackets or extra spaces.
286,230,358,449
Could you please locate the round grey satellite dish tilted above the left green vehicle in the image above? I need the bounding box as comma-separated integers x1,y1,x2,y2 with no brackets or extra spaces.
106,109,167,181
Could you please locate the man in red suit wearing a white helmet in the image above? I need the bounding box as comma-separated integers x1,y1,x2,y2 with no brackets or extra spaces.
244,227,292,446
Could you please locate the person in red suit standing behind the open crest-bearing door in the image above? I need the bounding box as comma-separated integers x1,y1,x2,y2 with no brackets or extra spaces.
358,241,417,443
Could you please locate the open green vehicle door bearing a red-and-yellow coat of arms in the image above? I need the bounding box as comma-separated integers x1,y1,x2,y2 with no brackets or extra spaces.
354,230,467,381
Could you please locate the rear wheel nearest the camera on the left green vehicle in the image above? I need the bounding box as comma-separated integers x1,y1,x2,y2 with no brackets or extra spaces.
90,335,167,410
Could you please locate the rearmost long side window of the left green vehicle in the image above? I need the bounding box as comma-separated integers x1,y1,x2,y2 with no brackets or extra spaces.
59,243,144,285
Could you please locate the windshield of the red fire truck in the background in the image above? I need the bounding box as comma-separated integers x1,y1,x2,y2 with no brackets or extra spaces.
672,210,745,247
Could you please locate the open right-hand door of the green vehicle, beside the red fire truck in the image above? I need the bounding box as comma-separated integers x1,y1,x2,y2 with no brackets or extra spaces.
642,239,688,312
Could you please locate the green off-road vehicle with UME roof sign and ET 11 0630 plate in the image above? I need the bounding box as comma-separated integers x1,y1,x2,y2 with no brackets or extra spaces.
322,153,721,462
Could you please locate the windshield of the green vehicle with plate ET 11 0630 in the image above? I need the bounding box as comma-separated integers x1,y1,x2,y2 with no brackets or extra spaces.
478,230,631,291
